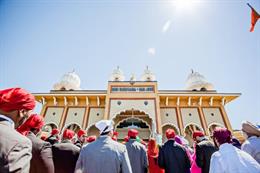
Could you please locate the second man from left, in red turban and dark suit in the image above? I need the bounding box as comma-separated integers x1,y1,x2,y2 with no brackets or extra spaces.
17,114,54,173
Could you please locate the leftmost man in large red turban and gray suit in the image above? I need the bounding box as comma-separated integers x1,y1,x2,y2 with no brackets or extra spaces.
0,88,35,173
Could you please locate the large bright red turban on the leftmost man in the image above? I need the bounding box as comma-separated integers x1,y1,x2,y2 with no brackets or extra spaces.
0,88,35,112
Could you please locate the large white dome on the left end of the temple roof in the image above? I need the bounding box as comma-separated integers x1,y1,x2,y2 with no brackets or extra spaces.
53,70,80,90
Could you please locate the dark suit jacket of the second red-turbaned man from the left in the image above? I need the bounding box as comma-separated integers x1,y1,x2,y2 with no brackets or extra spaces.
27,132,54,173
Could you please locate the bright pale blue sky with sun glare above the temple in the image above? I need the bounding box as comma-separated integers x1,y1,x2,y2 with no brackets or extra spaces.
0,0,260,129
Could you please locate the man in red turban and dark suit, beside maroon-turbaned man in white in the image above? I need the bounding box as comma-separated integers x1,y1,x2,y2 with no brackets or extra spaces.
192,131,217,173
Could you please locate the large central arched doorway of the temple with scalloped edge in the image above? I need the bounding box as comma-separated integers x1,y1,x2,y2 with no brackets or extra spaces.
113,109,153,141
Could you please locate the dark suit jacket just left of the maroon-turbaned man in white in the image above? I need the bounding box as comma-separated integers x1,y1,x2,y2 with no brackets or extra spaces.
196,140,217,173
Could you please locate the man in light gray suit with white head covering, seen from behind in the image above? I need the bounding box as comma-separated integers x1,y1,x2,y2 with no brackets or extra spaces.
75,120,132,173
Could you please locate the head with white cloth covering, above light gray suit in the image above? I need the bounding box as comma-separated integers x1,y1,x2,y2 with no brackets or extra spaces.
95,120,114,137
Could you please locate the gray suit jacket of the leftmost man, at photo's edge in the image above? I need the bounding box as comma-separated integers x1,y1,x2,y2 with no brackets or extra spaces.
0,119,32,173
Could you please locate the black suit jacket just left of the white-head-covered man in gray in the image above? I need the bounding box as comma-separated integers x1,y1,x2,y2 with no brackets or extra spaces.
52,141,80,173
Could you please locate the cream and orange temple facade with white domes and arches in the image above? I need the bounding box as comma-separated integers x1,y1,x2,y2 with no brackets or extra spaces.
34,67,240,145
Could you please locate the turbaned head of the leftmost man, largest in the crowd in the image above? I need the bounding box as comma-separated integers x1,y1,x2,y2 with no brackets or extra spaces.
0,88,35,128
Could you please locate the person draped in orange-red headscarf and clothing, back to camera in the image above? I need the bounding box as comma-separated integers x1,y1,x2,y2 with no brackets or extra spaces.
147,138,164,173
